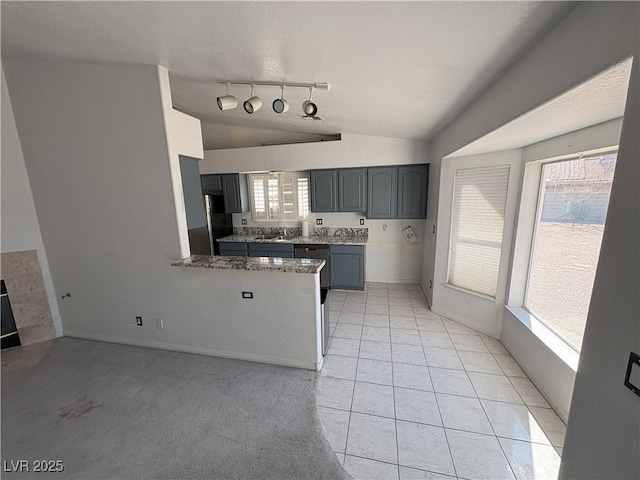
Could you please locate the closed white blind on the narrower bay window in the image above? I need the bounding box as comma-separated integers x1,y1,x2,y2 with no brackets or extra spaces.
448,166,509,297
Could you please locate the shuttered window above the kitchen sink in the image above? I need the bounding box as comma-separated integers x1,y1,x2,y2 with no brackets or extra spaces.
249,172,309,222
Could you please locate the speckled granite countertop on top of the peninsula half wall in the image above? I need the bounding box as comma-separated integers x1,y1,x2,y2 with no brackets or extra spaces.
171,255,325,273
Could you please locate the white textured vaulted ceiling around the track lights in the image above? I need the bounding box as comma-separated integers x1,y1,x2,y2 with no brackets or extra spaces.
1,1,570,148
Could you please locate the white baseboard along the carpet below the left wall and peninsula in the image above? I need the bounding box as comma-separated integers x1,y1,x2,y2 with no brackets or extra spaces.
64,330,318,370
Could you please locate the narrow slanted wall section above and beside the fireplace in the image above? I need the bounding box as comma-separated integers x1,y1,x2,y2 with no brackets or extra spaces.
0,67,62,336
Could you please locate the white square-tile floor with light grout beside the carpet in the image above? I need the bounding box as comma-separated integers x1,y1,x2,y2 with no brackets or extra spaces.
317,283,565,480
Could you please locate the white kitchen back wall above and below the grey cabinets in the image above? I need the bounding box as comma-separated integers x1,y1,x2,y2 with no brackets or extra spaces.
200,135,429,283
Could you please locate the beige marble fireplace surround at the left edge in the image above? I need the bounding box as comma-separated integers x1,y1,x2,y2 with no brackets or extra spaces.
0,250,56,346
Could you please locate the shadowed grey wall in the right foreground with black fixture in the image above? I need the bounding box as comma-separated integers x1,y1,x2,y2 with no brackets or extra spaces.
560,49,640,479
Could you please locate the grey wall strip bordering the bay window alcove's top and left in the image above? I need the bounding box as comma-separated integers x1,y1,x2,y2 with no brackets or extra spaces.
422,2,638,302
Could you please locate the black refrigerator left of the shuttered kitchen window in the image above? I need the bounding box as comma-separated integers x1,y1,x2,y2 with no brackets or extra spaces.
189,192,233,255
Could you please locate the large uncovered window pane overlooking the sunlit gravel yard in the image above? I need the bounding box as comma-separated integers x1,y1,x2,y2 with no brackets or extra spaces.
525,153,616,350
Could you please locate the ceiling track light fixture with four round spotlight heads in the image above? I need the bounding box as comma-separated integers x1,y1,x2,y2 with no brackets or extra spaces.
218,80,330,120
